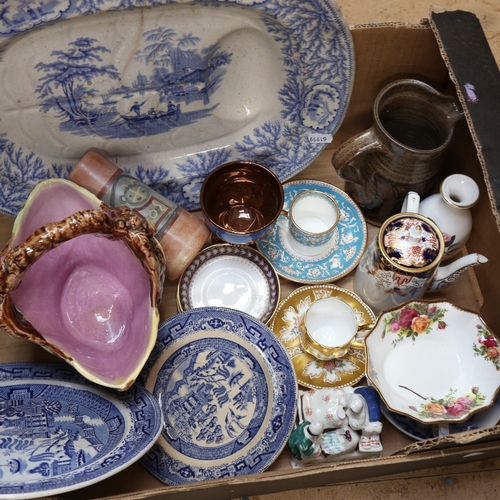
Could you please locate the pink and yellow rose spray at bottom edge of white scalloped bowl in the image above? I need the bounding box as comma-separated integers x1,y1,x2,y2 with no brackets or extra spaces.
409,387,485,420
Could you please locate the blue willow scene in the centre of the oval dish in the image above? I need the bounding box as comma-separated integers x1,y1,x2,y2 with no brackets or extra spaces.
0,385,120,478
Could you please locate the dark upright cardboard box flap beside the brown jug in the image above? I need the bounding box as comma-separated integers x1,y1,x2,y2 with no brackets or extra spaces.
429,10,500,229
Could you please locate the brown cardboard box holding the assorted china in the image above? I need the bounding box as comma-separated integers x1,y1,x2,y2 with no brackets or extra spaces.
0,7,500,500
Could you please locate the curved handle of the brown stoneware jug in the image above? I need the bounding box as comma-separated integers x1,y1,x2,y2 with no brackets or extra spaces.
332,127,387,184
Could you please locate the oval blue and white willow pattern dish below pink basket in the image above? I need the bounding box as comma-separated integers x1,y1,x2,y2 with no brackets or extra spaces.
0,363,162,499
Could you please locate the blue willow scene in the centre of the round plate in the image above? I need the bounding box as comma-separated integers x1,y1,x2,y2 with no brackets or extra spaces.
157,339,269,450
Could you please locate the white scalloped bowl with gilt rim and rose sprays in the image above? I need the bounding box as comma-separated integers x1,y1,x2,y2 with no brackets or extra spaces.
365,300,500,424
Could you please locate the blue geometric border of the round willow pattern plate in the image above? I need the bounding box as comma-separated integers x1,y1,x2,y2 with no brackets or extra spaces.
139,307,297,484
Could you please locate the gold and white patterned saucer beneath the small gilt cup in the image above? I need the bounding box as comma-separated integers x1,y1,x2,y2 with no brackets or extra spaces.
271,284,375,389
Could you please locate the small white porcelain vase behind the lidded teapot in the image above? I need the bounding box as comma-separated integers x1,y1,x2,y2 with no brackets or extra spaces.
419,174,479,260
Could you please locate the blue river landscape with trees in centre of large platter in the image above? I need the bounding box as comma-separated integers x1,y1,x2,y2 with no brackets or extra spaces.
35,30,231,138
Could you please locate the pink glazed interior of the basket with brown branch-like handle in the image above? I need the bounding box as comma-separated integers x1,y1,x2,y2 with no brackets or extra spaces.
0,180,165,389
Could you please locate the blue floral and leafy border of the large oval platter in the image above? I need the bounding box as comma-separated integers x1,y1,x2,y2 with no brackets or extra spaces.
0,0,354,215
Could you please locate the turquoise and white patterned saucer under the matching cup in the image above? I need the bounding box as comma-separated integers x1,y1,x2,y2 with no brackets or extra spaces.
257,180,367,284
